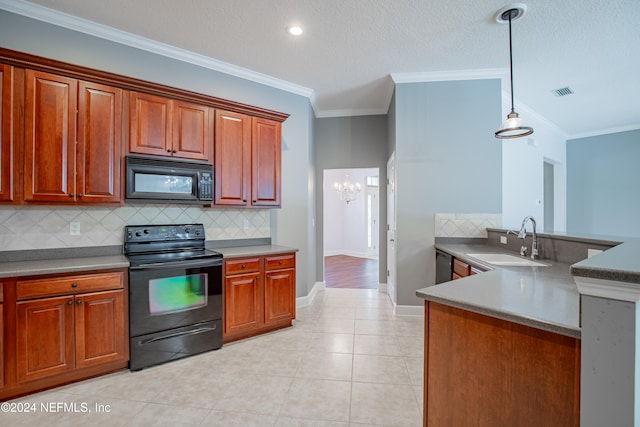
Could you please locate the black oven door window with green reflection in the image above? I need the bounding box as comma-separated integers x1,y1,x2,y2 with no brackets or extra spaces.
149,274,207,316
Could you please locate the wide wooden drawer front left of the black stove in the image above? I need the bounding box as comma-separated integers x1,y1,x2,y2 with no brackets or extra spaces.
16,272,124,300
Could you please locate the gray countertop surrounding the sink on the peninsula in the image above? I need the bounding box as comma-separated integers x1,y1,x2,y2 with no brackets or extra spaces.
416,244,581,338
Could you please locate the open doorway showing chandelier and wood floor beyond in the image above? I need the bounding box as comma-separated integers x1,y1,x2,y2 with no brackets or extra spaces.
323,168,380,289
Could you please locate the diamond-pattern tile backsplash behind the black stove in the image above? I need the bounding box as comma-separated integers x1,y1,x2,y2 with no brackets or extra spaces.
0,204,271,254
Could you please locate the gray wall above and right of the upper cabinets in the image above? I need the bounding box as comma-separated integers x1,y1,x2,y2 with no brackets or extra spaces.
0,10,316,296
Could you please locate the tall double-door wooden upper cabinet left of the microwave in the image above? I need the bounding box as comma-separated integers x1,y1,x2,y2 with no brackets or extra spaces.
24,70,122,203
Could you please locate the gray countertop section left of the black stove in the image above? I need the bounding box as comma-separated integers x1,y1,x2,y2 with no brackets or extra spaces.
0,255,129,279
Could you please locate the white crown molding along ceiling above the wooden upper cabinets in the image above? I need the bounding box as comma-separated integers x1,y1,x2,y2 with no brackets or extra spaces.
0,0,314,99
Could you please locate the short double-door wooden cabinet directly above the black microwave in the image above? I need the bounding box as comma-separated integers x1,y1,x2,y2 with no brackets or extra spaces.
129,92,213,162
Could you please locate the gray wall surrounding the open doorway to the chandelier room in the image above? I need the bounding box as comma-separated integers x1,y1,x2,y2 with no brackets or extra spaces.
313,116,387,283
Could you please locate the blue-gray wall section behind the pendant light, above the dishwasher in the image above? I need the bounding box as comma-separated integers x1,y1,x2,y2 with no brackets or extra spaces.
394,79,502,305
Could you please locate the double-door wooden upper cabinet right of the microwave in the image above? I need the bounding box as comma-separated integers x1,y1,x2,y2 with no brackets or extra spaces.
214,110,282,207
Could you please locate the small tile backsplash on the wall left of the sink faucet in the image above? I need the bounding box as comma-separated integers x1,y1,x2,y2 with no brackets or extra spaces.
435,213,502,238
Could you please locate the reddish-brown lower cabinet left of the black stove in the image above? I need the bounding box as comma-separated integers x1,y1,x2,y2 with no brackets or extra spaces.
0,269,129,398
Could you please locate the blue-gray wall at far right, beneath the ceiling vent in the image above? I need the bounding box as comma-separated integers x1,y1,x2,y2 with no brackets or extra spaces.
567,130,640,237
